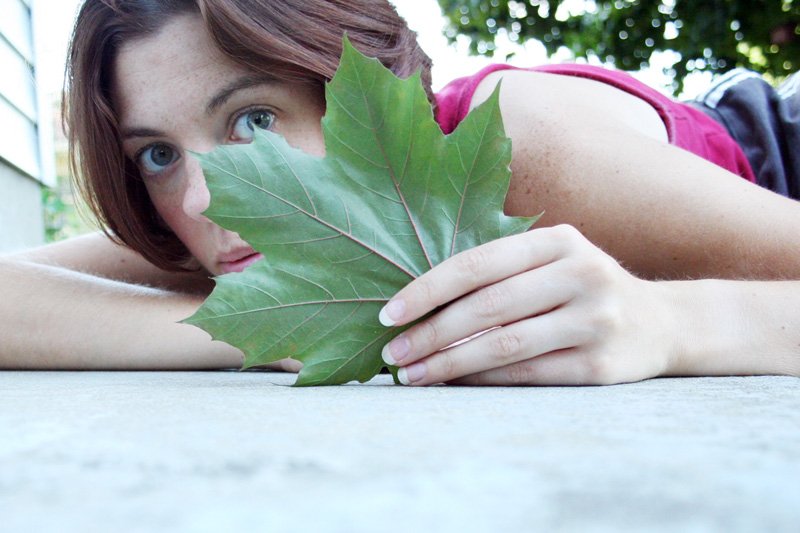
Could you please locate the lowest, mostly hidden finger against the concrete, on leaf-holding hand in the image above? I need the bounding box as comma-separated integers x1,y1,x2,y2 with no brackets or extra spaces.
448,349,599,387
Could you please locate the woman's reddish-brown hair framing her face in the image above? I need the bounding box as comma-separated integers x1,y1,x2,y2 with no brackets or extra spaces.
64,0,433,270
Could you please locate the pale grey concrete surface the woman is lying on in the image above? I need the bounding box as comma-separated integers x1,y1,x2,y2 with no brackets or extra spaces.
0,372,800,532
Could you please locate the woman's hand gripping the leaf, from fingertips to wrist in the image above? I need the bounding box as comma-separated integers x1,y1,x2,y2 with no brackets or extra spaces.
381,222,681,385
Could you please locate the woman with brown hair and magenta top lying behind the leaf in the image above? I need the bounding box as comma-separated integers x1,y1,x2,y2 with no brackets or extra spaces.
0,0,800,385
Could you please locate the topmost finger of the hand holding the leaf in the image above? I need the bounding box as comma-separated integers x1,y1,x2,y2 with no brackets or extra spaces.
380,226,585,326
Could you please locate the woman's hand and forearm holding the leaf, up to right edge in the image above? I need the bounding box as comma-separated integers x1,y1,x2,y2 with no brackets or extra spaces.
384,222,800,385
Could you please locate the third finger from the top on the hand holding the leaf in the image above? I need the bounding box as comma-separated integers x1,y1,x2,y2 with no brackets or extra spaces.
398,309,592,385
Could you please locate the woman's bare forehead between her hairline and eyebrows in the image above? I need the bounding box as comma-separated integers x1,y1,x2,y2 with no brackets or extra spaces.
113,15,247,124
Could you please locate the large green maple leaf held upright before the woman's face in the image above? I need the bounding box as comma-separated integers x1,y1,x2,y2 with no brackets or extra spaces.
186,39,535,385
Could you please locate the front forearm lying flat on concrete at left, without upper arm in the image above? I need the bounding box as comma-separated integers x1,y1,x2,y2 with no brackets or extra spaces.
0,260,242,370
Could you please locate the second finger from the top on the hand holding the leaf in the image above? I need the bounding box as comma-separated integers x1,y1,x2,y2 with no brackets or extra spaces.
382,261,581,366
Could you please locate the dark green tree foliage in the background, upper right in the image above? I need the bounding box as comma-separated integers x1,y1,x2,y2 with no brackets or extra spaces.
439,0,800,90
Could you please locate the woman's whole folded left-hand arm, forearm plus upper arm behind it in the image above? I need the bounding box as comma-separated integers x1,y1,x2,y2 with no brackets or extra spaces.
0,234,242,370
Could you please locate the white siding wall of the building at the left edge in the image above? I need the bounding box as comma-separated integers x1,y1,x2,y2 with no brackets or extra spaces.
0,0,48,252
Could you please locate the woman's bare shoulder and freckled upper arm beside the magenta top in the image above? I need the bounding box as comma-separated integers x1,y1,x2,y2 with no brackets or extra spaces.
475,68,800,279
